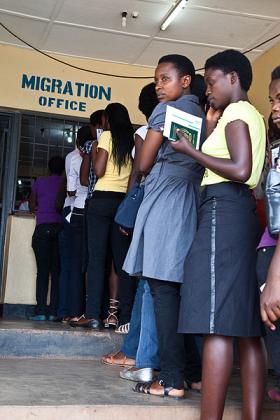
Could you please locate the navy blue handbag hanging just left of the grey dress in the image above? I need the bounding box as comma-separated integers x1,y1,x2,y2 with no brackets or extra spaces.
115,183,144,229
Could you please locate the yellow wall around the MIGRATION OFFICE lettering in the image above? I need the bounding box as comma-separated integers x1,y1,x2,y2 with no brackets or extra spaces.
0,45,154,124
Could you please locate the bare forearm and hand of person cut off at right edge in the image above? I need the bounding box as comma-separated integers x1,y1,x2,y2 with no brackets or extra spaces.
261,236,280,330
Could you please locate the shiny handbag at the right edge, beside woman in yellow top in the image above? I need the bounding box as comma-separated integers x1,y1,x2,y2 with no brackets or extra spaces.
265,146,280,235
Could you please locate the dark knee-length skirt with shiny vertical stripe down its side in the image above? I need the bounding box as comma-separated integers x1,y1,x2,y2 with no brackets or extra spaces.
179,182,264,337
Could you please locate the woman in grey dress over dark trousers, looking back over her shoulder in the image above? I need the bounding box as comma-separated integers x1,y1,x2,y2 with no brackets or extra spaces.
124,55,205,398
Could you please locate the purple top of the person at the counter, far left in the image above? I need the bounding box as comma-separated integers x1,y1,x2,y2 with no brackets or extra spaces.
32,175,62,225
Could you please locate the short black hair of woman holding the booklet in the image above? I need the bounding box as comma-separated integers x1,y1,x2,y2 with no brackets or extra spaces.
204,50,253,92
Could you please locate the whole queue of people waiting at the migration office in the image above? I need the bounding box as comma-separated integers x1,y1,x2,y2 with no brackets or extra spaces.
30,50,280,420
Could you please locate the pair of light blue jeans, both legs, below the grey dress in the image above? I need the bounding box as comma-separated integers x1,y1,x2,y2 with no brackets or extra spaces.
121,280,159,369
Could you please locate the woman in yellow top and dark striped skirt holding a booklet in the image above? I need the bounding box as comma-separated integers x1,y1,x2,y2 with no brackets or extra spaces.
173,50,266,420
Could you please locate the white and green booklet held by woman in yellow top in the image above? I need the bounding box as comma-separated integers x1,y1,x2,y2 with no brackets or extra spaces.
163,105,202,149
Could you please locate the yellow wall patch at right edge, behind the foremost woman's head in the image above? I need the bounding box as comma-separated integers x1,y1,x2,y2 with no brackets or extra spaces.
249,42,280,121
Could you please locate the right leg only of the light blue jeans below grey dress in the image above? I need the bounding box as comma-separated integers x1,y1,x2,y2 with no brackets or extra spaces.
135,280,160,369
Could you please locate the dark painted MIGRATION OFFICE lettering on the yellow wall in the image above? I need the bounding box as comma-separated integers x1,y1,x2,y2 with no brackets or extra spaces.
21,74,111,112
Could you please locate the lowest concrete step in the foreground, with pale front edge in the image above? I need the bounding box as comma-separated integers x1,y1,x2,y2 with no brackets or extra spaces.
0,359,280,420
